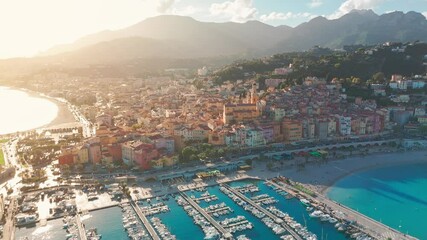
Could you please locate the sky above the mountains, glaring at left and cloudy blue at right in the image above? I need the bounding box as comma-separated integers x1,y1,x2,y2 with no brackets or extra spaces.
0,0,427,58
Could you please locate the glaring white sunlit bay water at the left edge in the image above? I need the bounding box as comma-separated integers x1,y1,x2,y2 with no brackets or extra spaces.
0,86,58,135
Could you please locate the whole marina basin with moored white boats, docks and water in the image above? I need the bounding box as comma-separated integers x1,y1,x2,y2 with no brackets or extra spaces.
14,179,398,240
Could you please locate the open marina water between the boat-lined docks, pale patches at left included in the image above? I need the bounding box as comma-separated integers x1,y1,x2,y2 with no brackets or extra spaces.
17,181,347,240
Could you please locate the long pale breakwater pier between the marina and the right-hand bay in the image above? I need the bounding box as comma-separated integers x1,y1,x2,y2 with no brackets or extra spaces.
266,180,416,240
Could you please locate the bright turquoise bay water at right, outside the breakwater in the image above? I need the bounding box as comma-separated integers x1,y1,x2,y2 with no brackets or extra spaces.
328,163,427,239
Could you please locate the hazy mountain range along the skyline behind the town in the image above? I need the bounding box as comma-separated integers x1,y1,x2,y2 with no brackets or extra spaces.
36,10,427,62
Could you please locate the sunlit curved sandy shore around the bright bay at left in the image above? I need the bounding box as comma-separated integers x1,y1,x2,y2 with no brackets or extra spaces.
1,86,80,135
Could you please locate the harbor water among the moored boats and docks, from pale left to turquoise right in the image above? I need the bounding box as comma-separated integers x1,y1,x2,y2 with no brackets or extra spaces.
17,180,358,240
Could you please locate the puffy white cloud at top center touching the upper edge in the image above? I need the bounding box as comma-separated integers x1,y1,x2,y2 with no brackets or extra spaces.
209,0,258,22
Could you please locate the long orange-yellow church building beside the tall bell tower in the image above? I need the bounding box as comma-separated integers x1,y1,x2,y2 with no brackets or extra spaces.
222,103,260,124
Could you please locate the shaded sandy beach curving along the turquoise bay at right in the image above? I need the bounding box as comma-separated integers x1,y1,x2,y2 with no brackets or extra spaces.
248,150,427,195
